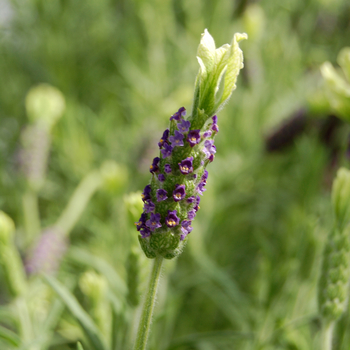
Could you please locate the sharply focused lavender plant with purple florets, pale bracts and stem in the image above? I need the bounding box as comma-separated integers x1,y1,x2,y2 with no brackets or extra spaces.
134,30,247,349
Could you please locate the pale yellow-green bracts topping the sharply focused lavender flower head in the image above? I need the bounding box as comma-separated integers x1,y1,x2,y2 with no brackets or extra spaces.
190,29,248,128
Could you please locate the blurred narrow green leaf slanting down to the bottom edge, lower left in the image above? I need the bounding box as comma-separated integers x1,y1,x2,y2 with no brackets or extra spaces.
44,275,107,350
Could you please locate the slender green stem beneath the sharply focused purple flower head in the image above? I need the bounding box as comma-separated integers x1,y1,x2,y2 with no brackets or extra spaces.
134,256,163,350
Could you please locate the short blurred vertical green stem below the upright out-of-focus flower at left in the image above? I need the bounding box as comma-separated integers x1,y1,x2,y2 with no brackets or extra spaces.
22,189,41,244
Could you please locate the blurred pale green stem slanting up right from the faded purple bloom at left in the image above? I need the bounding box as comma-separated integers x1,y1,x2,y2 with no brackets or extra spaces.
55,171,102,235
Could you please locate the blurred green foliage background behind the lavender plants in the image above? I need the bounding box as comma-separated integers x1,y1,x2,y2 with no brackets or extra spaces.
0,0,350,350
